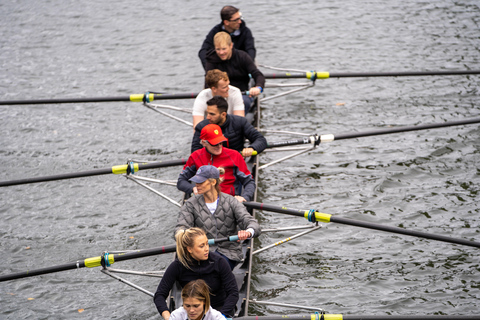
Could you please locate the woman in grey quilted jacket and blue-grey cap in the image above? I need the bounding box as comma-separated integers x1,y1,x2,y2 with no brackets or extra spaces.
175,165,261,269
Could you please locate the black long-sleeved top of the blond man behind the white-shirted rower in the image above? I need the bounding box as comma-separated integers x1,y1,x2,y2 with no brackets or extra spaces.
205,48,265,91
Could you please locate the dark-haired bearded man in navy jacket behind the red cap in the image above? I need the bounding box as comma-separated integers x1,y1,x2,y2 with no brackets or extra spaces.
192,96,267,157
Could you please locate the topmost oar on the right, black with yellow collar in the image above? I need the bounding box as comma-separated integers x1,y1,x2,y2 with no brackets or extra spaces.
263,70,480,80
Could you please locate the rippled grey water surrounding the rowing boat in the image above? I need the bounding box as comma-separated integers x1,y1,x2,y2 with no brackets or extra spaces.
0,0,480,319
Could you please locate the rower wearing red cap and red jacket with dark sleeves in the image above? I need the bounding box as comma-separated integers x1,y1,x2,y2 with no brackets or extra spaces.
177,123,256,202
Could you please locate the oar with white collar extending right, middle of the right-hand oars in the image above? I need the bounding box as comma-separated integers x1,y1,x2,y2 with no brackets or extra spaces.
254,118,480,155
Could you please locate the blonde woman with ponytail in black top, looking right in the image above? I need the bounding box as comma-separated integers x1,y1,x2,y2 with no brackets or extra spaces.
153,228,238,320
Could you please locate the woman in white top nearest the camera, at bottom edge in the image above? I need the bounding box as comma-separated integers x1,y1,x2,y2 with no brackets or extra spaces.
170,279,225,320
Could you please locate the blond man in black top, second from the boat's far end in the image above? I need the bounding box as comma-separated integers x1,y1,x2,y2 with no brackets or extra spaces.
205,32,265,114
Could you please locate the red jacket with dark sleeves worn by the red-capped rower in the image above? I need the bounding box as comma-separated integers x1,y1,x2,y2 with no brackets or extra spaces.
177,147,256,201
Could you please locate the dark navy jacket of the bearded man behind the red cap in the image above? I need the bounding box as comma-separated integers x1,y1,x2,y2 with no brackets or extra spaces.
192,114,267,153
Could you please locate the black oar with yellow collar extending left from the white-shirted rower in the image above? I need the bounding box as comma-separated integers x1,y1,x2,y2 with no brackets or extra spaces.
0,92,198,105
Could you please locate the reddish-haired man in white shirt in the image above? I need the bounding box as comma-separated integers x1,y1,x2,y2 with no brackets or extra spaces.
192,69,245,130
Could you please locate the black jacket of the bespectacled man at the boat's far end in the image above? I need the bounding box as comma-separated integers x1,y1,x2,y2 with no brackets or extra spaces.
198,20,257,69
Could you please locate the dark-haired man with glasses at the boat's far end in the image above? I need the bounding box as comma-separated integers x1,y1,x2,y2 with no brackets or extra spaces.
198,6,257,69
